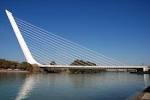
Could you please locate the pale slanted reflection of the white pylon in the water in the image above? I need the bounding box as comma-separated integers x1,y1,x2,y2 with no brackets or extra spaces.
15,75,35,100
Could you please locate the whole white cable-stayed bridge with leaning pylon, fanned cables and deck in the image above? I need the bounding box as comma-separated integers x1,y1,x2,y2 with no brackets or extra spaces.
6,10,148,71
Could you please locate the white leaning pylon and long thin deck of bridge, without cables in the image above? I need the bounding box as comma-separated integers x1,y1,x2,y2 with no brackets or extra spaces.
6,10,148,71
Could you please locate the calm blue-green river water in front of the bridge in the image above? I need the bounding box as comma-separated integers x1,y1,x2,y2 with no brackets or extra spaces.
0,72,150,100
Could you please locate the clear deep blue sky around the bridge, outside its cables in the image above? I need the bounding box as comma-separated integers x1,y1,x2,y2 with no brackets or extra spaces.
0,0,150,64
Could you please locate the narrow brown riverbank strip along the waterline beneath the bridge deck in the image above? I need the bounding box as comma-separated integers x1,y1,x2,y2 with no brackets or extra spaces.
0,65,146,74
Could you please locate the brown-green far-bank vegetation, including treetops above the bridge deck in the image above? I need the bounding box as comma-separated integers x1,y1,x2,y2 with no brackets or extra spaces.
0,59,148,74
